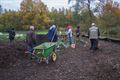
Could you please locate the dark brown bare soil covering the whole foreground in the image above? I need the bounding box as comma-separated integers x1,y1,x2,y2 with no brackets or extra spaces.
0,35,120,80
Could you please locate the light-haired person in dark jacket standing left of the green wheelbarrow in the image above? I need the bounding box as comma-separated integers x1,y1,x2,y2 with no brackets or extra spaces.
26,26,36,53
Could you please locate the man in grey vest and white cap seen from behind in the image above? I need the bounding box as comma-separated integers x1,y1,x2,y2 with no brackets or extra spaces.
88,23,100,50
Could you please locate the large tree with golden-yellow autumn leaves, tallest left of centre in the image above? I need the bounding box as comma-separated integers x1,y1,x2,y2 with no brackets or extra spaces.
20,0,50,28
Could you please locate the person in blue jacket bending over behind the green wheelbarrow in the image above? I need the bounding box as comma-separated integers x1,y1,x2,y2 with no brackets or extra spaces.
48,25,58,42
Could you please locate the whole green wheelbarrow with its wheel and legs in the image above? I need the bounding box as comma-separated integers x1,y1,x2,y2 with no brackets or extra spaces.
34,42,57,64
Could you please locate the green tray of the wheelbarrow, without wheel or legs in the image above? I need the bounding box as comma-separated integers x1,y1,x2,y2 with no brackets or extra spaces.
34,42,56,58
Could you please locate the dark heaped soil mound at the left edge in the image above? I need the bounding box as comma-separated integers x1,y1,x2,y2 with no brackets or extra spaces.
0,42,26,68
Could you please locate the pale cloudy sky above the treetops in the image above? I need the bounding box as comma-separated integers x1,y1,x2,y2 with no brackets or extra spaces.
0,0,69,11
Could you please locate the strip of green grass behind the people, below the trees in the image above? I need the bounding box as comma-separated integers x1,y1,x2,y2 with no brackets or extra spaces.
0,30,120,42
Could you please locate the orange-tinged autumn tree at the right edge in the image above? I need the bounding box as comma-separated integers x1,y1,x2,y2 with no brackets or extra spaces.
98,0,120,37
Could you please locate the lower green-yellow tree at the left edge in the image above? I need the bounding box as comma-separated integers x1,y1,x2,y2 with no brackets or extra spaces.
0,10,22,31
